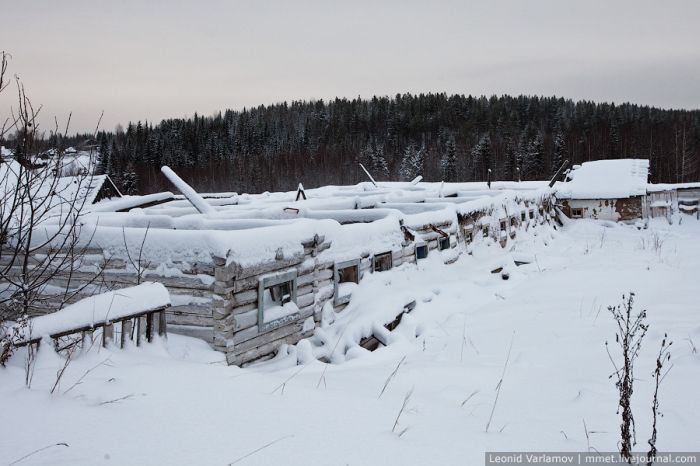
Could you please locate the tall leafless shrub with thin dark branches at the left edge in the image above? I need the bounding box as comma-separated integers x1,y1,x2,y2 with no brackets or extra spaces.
0,52,101,364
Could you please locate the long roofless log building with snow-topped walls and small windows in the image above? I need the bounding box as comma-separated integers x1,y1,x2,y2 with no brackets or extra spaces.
13,171,555,364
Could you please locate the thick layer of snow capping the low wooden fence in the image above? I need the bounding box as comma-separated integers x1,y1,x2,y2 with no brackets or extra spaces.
14,282,170,339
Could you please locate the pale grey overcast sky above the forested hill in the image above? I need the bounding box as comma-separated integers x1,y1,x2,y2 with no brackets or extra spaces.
0,0,700,132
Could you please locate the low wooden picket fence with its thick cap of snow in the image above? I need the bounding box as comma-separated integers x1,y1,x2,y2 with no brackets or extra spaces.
11,282,170,349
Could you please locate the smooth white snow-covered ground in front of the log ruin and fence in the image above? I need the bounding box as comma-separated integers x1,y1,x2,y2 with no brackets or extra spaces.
0,218,700,465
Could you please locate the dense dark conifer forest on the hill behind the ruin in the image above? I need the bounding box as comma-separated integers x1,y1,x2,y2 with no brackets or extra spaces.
21,94,700,193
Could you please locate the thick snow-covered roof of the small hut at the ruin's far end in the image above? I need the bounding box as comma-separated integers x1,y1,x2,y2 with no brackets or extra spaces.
555,159,649,199
